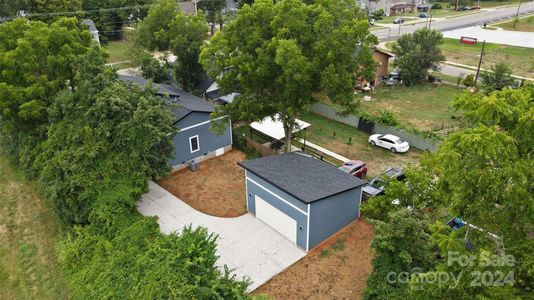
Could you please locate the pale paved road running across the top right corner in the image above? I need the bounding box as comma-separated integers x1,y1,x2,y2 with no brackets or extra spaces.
372,2,534,42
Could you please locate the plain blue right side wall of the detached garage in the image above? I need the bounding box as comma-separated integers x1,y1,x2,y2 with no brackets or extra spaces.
309,187,362,249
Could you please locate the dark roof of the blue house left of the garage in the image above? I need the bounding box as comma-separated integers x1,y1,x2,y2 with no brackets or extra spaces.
119,75,214,121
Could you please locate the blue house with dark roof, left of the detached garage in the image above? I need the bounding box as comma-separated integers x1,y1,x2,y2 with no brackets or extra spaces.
119,75,232,170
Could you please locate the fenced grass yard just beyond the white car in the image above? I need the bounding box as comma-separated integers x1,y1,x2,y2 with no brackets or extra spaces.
361,84,462,130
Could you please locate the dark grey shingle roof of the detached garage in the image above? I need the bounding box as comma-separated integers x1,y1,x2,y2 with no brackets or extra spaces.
238,152,365,204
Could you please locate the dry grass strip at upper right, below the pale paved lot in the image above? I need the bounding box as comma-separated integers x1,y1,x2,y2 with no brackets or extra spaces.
440,38,534,77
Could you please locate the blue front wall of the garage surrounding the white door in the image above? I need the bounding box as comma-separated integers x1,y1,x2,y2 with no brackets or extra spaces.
245,171,308,250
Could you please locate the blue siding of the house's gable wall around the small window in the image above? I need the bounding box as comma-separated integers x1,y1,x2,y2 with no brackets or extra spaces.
171,112,232,166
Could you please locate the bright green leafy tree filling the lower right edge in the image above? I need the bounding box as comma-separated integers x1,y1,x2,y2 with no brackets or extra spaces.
364,85,534,299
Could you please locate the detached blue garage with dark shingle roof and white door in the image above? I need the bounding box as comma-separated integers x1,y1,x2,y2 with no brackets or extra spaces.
238,152,365,251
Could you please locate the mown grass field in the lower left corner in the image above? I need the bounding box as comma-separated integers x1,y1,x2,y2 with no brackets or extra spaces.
0,156,69,299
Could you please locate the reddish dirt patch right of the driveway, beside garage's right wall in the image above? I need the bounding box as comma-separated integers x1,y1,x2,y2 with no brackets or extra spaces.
253,217,373,299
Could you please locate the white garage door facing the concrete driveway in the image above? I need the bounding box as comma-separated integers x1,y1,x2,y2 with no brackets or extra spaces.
255,195,297,244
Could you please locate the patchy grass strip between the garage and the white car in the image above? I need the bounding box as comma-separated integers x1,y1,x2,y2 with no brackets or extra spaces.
299,113,422,176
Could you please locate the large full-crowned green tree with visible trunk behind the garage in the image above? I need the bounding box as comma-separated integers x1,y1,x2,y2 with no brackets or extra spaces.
201,0,376,149
